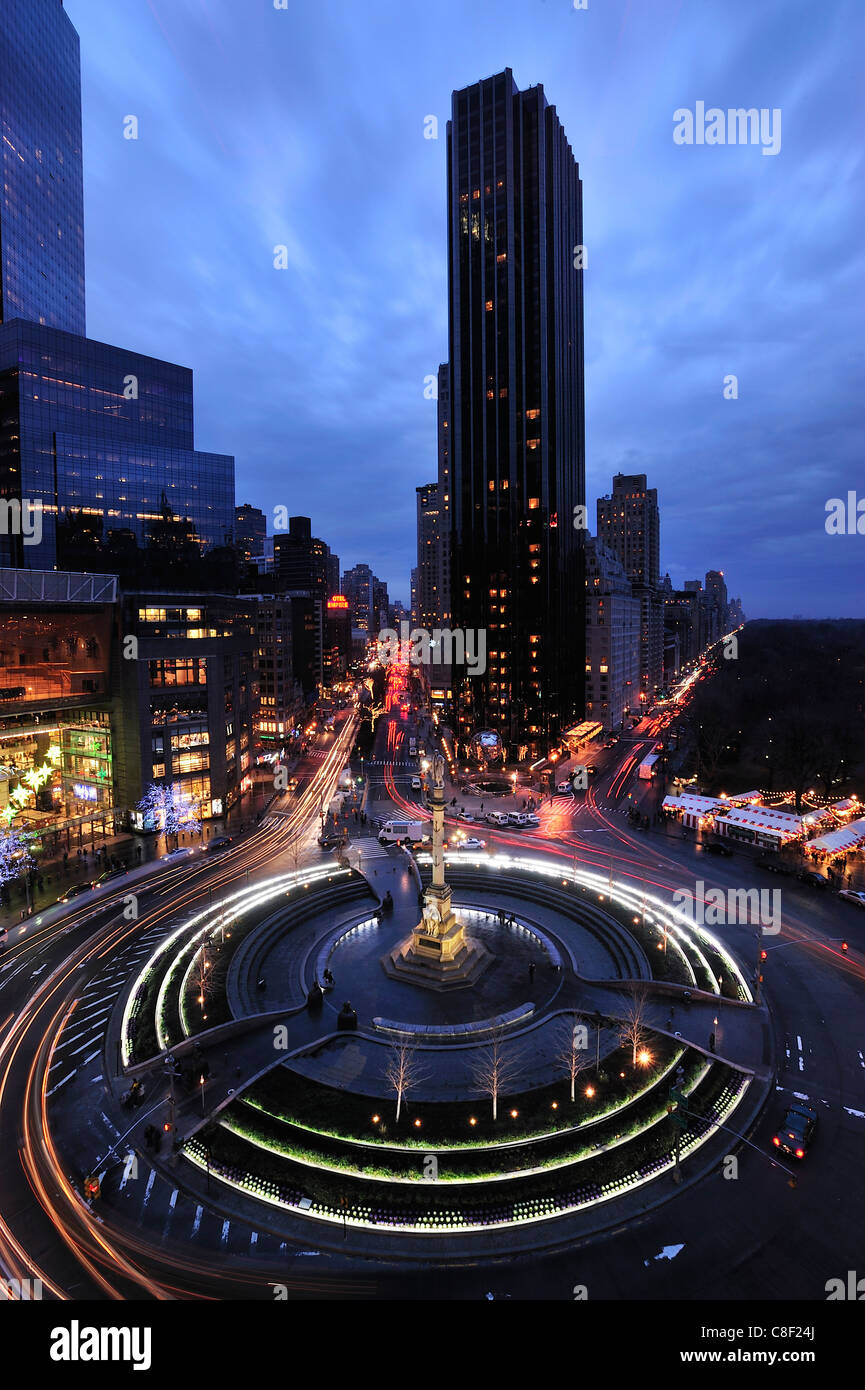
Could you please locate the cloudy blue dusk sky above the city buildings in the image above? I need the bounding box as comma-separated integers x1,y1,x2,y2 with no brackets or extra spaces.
65,0,865,617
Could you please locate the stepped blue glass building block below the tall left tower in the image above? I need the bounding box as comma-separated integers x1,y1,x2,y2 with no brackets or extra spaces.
0,320,234,570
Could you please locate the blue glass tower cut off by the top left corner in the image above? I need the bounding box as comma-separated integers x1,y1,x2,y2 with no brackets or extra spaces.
0,0,86,336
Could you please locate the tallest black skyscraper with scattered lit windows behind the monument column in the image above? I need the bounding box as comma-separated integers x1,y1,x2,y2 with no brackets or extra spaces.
448,70,585,752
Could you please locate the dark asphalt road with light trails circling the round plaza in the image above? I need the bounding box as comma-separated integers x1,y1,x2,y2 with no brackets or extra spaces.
0,703,865,1301
